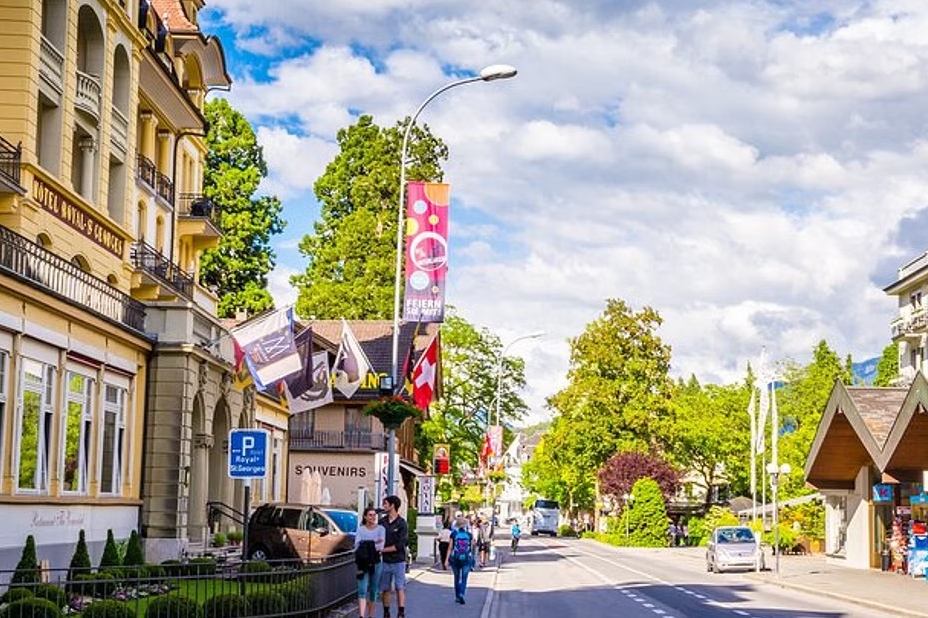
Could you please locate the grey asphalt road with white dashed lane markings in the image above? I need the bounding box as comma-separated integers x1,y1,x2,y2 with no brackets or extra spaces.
396,538,904,618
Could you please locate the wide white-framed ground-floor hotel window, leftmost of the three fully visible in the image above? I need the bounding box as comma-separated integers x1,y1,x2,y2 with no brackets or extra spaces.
16,358,55,493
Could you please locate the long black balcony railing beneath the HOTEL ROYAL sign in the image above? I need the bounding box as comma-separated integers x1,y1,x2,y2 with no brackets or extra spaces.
0,226,145,332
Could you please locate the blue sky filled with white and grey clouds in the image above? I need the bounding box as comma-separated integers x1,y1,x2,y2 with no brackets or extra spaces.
200,0,928,422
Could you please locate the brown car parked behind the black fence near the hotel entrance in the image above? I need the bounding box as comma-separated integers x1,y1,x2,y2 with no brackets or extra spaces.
248,502,354,561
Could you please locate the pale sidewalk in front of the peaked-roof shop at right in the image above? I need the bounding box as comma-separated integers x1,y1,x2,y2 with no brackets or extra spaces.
748,555,928,618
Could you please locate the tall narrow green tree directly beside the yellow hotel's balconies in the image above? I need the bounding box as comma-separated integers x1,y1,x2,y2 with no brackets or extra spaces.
200,99,285,317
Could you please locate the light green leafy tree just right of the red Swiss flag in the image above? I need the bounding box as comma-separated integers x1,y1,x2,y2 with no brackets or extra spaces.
416,308,528,480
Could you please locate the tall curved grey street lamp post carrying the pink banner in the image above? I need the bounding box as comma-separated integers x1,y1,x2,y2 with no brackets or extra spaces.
380,64,517,494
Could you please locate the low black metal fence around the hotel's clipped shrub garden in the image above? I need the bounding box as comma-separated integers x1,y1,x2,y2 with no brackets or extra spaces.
0,552,357,618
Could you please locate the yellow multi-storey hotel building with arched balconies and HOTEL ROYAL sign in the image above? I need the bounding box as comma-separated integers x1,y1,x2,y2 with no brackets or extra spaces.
0,0,286,566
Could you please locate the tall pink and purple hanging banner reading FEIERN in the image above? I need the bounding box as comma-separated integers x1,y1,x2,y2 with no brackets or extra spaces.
403,182,451,322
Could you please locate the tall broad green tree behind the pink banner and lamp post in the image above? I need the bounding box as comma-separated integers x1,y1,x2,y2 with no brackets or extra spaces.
291,115,448,320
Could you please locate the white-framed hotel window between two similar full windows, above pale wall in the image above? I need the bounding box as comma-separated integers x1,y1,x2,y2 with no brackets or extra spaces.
61,372,94,494
